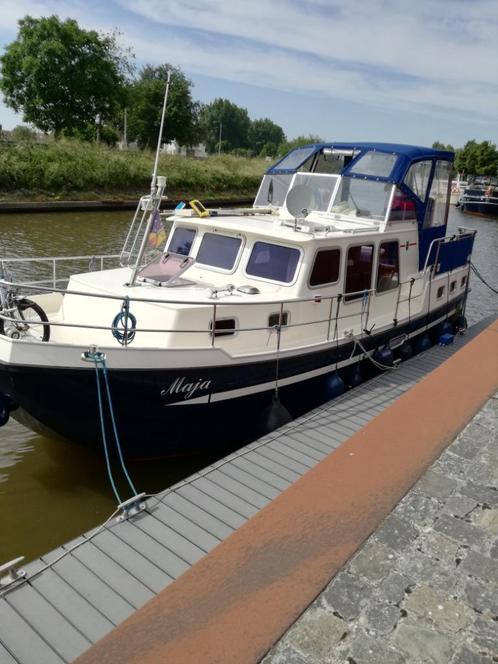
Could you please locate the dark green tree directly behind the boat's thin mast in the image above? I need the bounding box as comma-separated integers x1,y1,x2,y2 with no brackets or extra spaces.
127,64,199,147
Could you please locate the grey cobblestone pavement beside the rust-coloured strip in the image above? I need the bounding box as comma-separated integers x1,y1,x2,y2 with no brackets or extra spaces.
263,394,498,664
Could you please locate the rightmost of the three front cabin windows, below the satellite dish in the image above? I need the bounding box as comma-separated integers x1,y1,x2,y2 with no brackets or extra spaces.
246,242,299,284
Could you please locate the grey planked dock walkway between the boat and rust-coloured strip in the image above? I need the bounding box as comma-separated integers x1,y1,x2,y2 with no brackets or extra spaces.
0,319,490,664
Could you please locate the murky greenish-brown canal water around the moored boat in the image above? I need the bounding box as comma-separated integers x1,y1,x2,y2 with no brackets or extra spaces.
0,207,498,564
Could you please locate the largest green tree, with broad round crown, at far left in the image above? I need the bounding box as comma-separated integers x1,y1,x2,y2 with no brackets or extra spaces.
0,16,129,136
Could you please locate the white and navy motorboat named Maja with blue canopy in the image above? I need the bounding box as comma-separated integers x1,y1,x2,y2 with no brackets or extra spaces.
0,143,475,457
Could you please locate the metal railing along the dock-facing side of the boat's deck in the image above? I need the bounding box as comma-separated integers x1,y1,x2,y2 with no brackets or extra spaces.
0,268,436,350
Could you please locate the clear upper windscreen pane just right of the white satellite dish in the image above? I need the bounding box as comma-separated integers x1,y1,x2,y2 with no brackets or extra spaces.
330,176,392,221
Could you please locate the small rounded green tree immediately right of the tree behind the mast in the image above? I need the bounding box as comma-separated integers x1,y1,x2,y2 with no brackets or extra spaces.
200,99,251,152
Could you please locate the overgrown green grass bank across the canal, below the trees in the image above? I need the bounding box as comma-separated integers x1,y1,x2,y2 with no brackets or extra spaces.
0,140,268,201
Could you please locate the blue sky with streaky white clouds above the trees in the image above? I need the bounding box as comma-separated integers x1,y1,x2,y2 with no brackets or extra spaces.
0,0,498,147
